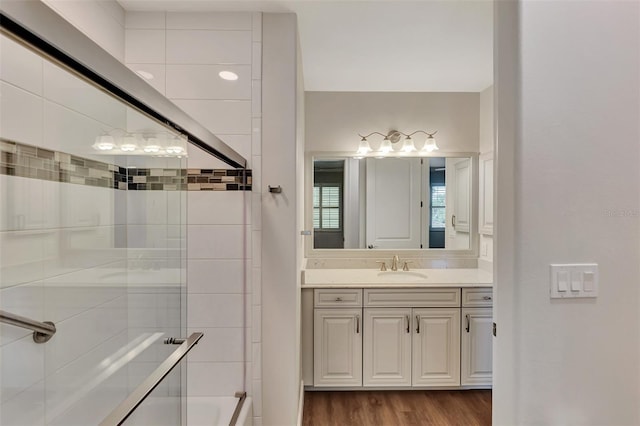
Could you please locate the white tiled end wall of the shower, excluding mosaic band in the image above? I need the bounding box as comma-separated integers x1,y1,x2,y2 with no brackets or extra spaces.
126,12,262,419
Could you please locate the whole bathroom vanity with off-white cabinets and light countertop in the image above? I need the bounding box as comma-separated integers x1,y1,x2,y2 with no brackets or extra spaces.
302,269,493,389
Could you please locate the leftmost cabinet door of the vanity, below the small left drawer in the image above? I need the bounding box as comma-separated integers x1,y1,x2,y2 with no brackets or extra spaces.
313,308,362,387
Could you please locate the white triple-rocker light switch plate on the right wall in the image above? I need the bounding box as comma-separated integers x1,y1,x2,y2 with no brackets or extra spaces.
549,263,598,299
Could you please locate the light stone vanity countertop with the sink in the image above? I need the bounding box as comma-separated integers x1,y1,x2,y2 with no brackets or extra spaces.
302,269,493,288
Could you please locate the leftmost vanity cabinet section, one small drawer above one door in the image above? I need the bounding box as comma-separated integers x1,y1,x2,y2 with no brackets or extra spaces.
313,289,362,387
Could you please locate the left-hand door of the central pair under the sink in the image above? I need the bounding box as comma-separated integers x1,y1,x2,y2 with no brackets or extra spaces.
362,308,411,386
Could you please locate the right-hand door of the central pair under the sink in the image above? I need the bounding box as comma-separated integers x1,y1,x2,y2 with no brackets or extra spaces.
412,308,460,386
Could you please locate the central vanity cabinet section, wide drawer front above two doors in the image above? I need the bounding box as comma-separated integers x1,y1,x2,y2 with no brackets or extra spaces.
363,288,460,387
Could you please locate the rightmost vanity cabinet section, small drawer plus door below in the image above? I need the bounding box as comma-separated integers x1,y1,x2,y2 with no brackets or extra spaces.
460,289,493,387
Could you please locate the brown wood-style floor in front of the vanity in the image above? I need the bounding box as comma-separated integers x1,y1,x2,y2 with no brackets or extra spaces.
302,390,491,426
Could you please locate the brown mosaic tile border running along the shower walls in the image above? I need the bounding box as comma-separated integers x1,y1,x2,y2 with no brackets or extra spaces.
0,139,252,191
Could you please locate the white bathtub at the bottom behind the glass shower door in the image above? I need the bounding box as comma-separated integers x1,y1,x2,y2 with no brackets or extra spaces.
125,396,253,426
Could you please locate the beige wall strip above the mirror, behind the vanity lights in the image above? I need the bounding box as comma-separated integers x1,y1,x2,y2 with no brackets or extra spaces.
305,92,480,152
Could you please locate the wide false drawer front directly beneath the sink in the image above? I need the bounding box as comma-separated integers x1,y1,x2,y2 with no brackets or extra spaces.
364,287,460,308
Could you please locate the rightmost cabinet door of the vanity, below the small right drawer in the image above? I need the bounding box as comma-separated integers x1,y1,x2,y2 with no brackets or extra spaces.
461,308,493,386
